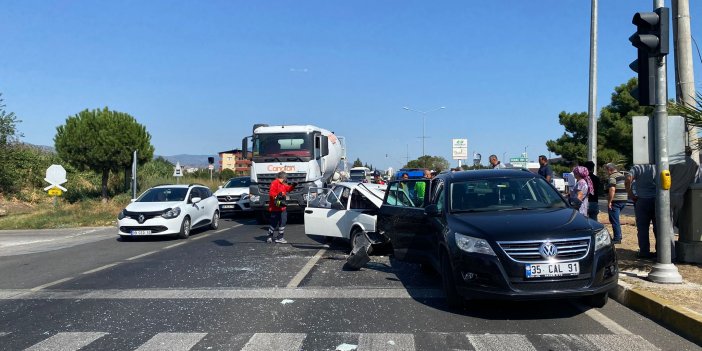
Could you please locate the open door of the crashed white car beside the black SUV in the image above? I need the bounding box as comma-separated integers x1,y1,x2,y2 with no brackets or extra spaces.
305,186,349,239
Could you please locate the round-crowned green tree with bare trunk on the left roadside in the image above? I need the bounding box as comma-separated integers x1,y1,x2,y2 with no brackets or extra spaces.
54,107,154,201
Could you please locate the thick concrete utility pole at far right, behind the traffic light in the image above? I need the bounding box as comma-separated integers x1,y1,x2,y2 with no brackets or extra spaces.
672,0,700,162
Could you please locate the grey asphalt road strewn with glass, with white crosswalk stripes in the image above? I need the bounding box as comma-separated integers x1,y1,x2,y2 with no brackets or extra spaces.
0,219,700,351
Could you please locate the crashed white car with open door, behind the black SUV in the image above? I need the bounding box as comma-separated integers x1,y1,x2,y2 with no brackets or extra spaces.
305,182,387,251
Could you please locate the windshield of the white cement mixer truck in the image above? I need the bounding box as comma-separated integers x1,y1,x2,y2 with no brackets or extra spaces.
253,133,314,157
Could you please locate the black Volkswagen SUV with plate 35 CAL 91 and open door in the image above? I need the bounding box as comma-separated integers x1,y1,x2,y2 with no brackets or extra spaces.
377,170,618,307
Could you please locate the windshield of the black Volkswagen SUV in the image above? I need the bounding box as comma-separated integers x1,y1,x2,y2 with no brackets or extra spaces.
449,177,567,212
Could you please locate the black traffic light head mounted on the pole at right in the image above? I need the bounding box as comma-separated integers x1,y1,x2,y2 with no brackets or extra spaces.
629,7,670,106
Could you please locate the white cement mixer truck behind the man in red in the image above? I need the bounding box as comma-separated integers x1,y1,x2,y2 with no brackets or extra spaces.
241,124,346,224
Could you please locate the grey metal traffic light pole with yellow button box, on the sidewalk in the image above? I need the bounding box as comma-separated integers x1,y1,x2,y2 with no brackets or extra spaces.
648,0,682,283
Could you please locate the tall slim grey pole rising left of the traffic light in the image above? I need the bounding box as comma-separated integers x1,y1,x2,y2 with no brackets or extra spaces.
588,0,597,174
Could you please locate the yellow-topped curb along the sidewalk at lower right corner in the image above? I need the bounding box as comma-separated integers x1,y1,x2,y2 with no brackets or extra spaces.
610,280,702,345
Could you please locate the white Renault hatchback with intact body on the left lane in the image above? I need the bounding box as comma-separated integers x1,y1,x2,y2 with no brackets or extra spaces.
117,184,219,239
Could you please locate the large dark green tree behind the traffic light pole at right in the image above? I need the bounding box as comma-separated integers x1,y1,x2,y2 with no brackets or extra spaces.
546,78,652,166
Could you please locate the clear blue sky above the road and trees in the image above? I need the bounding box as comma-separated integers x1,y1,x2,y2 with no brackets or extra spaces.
0,0,702,168
